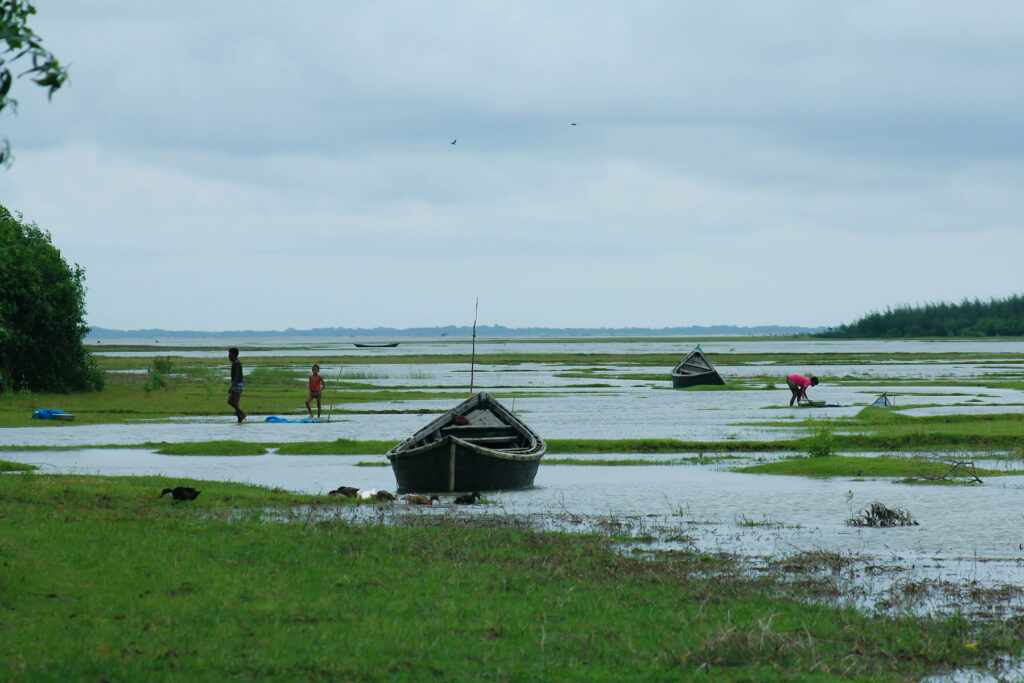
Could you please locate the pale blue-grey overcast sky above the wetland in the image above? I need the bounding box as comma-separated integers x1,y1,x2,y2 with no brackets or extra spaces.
0,0,1024,330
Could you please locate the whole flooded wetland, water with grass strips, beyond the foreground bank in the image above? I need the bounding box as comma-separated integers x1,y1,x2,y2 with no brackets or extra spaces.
0,338,1024,626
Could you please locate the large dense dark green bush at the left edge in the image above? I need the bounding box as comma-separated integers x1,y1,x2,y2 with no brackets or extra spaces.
0,206,103,392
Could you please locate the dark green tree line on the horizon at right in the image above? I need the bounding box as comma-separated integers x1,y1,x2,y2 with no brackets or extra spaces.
815,294,1024,339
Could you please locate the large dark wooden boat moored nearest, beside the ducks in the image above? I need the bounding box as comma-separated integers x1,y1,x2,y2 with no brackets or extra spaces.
387,391,548,492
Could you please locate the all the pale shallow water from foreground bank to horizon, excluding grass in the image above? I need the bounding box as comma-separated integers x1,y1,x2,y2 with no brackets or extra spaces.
6,338,1024,618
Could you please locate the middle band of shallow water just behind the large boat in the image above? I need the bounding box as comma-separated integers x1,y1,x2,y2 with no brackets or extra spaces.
6,370,1024,446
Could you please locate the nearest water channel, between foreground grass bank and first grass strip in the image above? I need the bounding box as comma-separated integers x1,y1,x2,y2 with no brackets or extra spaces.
12,450,1024,608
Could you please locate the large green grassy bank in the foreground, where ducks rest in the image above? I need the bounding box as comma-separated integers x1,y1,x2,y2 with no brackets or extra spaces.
0,474,1024,681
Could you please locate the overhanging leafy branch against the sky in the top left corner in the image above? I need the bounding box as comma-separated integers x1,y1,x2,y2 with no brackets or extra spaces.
0,0,68,165
